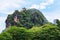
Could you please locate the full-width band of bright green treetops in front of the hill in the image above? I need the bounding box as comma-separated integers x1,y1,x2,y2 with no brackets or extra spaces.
0,23,60,40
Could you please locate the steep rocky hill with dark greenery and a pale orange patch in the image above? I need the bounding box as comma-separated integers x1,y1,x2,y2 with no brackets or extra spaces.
6,9,48,28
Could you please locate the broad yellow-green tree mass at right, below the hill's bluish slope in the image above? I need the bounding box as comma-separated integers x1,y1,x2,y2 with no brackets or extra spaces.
31,24,60,40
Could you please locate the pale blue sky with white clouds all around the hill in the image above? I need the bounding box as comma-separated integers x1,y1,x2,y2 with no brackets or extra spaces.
0,0,60,32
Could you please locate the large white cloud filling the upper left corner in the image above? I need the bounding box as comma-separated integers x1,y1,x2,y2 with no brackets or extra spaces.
0,0,27,14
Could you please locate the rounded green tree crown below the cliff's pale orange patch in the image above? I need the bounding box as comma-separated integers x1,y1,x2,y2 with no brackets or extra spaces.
5,26,32,40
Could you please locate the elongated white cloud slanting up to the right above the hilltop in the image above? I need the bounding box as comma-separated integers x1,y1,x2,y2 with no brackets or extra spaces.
30,0,54,9
